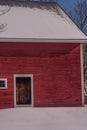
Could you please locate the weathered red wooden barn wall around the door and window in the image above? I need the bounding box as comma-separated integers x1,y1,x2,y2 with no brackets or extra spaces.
0,43,82,108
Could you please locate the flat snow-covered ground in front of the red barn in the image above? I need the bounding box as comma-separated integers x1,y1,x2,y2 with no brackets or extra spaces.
0,107,87,130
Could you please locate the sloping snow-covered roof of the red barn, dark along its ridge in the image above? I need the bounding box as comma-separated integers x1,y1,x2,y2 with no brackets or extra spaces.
0,2,87,41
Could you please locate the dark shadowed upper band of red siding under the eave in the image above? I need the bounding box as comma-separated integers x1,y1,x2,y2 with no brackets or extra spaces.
0,42,77,57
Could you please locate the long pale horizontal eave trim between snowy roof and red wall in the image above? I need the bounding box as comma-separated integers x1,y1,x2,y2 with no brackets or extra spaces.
0,38,87,43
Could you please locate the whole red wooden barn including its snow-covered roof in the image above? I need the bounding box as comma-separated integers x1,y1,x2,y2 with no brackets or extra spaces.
0,2,87,108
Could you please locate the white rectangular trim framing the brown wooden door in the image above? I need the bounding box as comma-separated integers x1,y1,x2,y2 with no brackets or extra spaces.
14,74,34,107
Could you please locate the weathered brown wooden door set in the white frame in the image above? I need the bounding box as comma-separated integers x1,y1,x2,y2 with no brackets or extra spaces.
16,77,31,105
